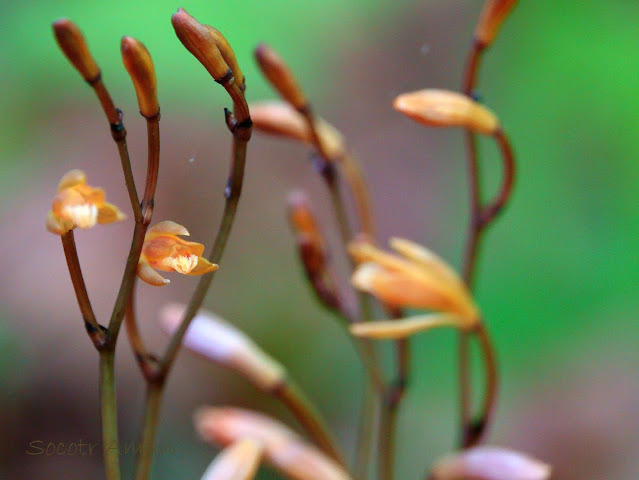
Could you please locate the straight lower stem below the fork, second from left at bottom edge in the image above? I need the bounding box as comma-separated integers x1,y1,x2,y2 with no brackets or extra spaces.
135,381,164,480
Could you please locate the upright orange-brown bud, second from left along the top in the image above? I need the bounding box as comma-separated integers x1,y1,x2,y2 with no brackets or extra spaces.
120,37,160,118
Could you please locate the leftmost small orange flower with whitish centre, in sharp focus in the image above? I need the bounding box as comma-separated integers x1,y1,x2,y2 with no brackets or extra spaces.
47,170,126,235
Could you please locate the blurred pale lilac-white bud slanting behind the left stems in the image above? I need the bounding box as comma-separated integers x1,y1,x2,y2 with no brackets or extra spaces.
160,304,286,392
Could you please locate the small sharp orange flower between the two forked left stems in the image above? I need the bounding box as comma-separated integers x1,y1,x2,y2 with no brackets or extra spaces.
138,220,218,287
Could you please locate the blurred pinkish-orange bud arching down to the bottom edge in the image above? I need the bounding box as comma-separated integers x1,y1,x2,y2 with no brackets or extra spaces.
194,407,349,480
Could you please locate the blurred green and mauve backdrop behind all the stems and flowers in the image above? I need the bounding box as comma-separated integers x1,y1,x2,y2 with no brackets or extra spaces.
0,0,639,480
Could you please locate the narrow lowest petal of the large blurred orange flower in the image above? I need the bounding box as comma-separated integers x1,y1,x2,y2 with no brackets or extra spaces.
349,313,477,340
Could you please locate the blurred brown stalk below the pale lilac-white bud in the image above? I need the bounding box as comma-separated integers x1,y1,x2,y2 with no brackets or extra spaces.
274,379,345,465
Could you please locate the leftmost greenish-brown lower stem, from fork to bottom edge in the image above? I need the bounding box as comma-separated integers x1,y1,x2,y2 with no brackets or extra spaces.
100,349,120,480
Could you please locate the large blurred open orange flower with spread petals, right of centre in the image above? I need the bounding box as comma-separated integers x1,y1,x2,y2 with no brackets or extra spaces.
349,238,479,338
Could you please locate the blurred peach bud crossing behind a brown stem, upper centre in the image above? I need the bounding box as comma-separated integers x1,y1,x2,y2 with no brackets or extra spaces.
251,101,346,160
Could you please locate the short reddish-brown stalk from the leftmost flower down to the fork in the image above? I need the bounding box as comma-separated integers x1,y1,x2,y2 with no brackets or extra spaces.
62,230,106,349
